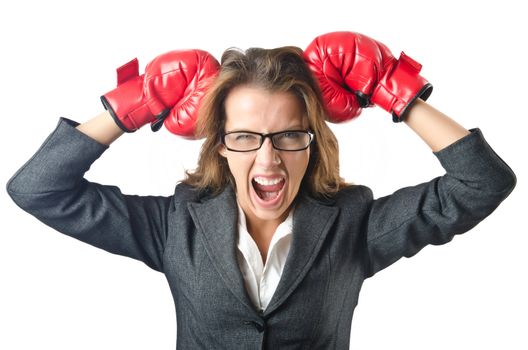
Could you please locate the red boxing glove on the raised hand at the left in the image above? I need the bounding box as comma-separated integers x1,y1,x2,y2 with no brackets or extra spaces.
101,50,219,138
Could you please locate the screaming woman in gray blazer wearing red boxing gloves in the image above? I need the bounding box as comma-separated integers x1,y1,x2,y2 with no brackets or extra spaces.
8,33,515,349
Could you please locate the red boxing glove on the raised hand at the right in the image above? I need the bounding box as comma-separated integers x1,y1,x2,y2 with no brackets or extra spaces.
305,32,433,122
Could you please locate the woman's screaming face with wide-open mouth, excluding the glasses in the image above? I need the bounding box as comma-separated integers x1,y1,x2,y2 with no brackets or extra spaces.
220,86,310,224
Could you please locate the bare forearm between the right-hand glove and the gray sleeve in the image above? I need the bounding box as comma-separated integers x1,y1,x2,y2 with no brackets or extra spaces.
403,98,470,152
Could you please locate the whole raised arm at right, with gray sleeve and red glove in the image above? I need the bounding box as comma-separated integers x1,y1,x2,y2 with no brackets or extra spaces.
305,32,516,276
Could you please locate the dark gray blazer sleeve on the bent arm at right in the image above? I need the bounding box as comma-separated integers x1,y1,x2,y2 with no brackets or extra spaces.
366,129,516,276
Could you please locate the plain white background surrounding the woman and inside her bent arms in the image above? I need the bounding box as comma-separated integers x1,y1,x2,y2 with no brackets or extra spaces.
0,0,528,349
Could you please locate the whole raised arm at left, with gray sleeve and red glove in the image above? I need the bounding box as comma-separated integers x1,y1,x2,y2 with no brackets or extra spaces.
6,50,217,271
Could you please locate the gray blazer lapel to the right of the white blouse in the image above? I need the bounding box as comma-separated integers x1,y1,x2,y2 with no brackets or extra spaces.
264,195,339,315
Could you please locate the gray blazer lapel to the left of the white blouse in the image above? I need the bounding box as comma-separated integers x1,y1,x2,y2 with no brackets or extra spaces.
188,187,255,311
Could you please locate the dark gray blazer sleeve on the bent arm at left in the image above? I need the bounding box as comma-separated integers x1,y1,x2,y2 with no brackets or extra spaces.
7,118,171,271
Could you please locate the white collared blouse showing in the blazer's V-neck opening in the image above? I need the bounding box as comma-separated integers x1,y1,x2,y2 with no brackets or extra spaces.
237,205,293,310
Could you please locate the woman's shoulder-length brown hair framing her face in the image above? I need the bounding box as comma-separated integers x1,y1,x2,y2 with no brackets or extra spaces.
183,46,346,197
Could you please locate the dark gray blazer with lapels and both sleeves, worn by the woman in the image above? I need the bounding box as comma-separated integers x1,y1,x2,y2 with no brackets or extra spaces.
7,119,516,350
